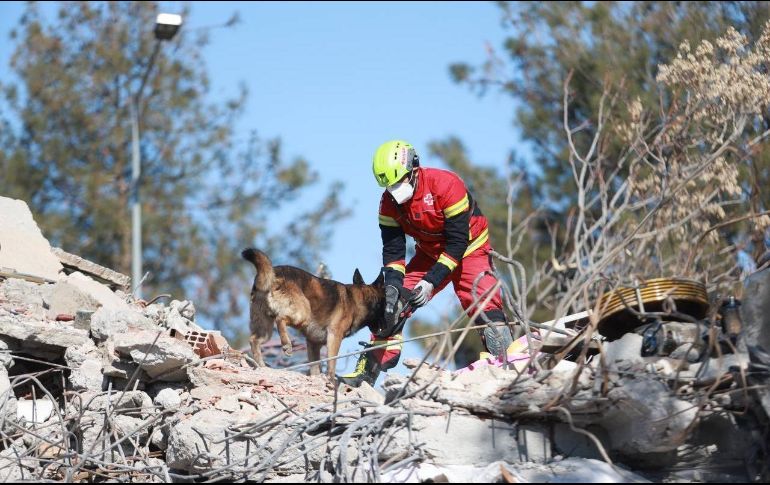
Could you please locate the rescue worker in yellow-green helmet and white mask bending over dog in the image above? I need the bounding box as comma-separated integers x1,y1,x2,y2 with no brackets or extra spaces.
339,140,513,387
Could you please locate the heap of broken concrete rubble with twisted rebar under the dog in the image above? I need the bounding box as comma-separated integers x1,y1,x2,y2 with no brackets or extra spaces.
0,197,770,483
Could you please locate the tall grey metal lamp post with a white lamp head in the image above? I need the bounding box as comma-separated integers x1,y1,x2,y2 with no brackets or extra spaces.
129,13,182,297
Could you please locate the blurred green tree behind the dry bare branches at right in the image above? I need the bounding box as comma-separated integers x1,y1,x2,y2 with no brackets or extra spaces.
450,2,770,256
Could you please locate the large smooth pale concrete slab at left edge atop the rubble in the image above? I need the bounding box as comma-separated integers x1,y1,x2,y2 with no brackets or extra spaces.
0,197,62,280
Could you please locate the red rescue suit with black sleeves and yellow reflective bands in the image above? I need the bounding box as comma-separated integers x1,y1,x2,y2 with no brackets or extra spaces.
379,168,503,321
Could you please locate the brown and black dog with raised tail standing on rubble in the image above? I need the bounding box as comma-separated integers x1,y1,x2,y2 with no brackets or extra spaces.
241,248,385,380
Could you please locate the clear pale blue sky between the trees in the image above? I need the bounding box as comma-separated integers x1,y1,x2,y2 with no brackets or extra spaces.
0,2,520,376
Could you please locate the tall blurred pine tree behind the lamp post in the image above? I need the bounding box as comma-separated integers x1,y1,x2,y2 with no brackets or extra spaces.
0,2,346,344
